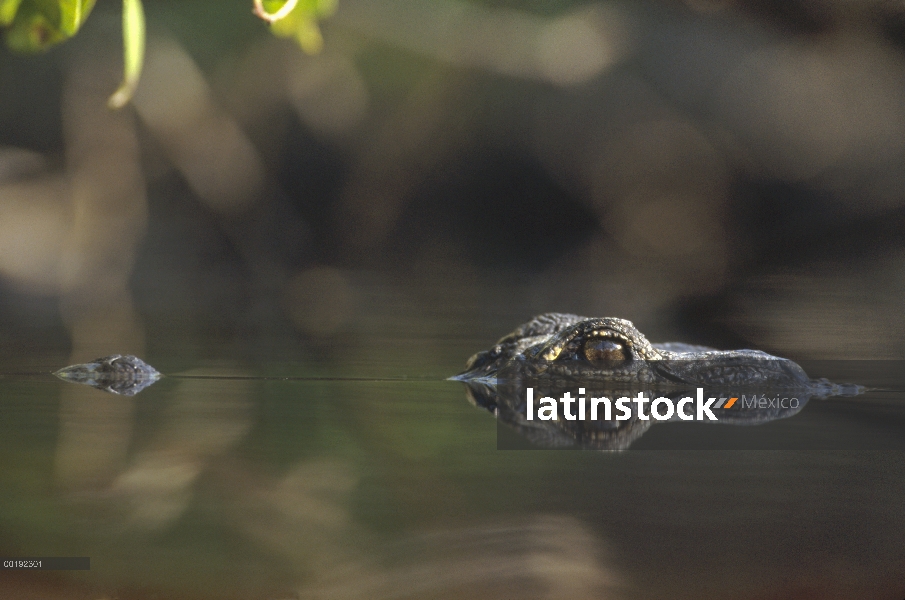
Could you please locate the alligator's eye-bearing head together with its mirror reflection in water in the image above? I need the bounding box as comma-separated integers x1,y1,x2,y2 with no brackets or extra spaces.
453,313,864,450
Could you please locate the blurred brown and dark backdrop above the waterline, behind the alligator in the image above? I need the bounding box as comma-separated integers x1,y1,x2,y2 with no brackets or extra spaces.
0,0,905,370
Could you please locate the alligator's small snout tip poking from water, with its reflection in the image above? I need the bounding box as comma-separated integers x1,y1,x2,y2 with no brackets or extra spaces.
54,354,161,396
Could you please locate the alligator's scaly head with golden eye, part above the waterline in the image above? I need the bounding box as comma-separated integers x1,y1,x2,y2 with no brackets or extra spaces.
456,313,863,397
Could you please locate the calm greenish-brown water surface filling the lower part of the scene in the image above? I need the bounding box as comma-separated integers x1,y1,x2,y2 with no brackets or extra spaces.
0,340,905,599
